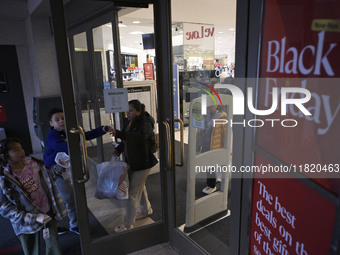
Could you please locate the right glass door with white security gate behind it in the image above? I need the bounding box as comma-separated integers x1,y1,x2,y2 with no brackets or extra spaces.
170,1,242,254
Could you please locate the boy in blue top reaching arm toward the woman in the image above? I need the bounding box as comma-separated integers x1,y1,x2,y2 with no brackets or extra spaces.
43,108,114,234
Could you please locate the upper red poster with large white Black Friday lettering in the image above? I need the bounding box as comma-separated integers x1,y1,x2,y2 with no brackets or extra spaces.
256,0,340,185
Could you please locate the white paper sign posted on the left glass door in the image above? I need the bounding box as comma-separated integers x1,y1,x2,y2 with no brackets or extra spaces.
103,88,129,113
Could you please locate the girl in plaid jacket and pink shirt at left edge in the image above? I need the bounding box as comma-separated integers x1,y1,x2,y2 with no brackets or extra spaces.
0,138,67,255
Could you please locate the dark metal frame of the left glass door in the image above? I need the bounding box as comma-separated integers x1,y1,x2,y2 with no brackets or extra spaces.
50,0,169,254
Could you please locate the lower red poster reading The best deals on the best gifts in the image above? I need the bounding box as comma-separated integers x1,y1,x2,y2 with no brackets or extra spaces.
249,170,336,255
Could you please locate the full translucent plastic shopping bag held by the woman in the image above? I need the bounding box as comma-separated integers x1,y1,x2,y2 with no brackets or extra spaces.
95,156,129,199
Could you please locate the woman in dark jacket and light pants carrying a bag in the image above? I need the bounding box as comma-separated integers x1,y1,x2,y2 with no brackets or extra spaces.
113,100,158,232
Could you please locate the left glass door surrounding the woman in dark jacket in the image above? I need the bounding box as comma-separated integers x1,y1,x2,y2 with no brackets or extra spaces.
51,0,170,254
